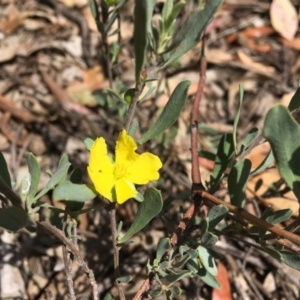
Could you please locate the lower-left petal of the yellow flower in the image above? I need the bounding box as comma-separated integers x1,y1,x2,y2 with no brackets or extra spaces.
88,166,115,201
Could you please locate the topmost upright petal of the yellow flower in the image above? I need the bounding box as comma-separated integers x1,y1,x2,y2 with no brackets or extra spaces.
116,129,139,164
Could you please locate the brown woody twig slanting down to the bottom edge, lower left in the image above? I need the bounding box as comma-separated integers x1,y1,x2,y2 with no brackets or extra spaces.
38,220,99,300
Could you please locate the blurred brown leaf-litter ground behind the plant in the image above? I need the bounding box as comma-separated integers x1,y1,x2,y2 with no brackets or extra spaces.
0,0,300,300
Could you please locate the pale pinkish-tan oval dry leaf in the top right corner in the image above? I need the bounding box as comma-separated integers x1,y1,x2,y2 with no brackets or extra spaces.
270,0,298,40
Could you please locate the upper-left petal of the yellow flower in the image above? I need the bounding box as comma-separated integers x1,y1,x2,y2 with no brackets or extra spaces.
89,137,114,173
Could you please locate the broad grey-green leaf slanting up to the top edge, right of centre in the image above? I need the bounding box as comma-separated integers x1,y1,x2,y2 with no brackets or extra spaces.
162,0,222,68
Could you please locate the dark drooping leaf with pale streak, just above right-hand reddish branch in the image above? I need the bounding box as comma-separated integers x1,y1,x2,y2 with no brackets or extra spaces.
228,159,251,207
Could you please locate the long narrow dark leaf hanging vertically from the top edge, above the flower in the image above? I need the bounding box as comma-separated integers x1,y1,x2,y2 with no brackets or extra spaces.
133,0,156,84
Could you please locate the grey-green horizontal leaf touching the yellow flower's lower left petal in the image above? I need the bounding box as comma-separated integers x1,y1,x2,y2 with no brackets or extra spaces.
52,181,98,202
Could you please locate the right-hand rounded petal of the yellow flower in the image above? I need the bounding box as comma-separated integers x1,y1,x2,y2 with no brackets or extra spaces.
126,152,162,184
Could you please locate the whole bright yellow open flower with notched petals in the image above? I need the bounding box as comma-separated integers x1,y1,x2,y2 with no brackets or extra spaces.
88,130,162,204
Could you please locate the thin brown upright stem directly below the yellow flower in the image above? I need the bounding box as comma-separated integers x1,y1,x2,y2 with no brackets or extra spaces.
109,203,126,300
